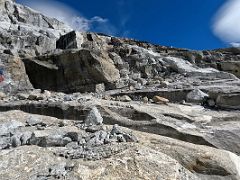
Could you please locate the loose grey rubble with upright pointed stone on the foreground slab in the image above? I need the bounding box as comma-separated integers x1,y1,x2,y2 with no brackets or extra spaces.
0,107,138,160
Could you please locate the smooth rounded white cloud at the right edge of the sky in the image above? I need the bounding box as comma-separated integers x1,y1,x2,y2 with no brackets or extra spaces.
213,0,240,46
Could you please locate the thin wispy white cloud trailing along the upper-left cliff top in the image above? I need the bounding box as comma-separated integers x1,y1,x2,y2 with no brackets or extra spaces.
19,0,116,35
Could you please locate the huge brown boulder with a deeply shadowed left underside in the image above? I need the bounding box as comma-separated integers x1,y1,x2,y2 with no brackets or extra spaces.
24,49,120,92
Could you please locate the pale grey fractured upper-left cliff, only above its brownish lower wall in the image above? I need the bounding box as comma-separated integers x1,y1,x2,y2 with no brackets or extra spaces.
0,1,71,55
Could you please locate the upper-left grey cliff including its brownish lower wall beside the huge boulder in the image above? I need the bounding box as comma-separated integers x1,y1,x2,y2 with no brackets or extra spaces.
0,0,71,93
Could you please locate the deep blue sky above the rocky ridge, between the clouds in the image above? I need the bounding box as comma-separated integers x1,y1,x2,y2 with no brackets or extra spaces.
17,0,239,50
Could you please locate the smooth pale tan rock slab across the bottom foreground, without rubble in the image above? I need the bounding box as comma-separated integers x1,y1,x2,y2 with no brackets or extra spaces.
0,111,240,180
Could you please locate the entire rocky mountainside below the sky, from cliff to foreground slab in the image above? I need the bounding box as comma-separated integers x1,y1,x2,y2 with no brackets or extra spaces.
0,0,240,180
